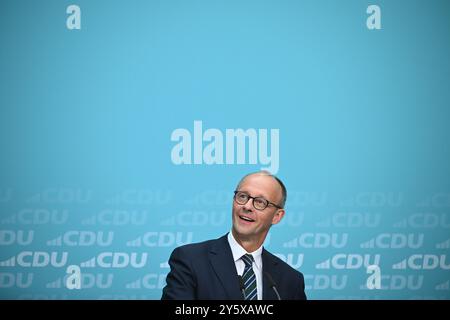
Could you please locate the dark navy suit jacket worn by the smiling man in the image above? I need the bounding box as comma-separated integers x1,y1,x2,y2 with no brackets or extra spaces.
161,235,306,300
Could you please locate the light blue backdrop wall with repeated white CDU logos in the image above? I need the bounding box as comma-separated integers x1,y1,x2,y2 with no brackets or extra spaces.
0,0,450,299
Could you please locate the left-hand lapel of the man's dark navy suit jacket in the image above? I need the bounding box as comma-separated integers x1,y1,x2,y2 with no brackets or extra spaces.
209,235,242,300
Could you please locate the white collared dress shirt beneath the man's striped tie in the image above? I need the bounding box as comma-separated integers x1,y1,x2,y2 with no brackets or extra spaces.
228,231,263,300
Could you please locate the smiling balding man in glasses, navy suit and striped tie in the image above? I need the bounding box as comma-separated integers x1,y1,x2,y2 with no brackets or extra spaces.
162,171,306,300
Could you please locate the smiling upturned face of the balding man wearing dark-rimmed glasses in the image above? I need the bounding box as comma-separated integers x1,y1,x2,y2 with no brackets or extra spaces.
233,174,284,242
